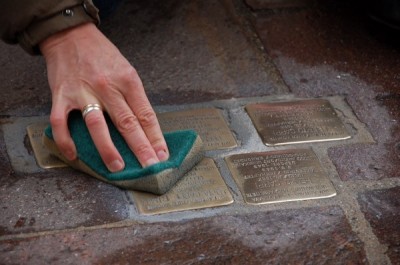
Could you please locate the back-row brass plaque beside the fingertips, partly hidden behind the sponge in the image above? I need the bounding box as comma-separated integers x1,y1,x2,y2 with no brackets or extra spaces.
157,108,237,150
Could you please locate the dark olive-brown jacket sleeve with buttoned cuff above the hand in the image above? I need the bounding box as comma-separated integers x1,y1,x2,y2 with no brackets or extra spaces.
0,0,99,54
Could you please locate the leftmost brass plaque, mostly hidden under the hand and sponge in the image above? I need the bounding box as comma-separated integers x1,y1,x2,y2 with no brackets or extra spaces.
26,122,67,168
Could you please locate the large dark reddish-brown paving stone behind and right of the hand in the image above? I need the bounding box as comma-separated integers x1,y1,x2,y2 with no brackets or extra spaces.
102,0,287,105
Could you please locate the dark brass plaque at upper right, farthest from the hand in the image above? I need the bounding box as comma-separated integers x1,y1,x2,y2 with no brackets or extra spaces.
246,99,351,146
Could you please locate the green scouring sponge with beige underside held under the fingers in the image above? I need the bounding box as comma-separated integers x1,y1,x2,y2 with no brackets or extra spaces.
43,111,204,194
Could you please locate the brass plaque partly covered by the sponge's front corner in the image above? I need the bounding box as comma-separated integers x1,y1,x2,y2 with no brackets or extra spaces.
130,158,233,215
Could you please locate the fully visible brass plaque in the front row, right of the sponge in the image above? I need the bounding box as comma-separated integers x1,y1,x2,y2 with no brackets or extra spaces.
225,149,336,204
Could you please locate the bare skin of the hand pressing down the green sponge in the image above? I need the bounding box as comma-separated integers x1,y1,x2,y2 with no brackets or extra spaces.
39,23,169,172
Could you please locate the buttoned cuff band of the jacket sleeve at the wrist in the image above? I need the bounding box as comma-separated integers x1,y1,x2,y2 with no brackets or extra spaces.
18,0,100,55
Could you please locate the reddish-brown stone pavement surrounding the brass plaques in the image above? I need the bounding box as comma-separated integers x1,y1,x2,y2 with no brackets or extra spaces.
0,0,400,264
